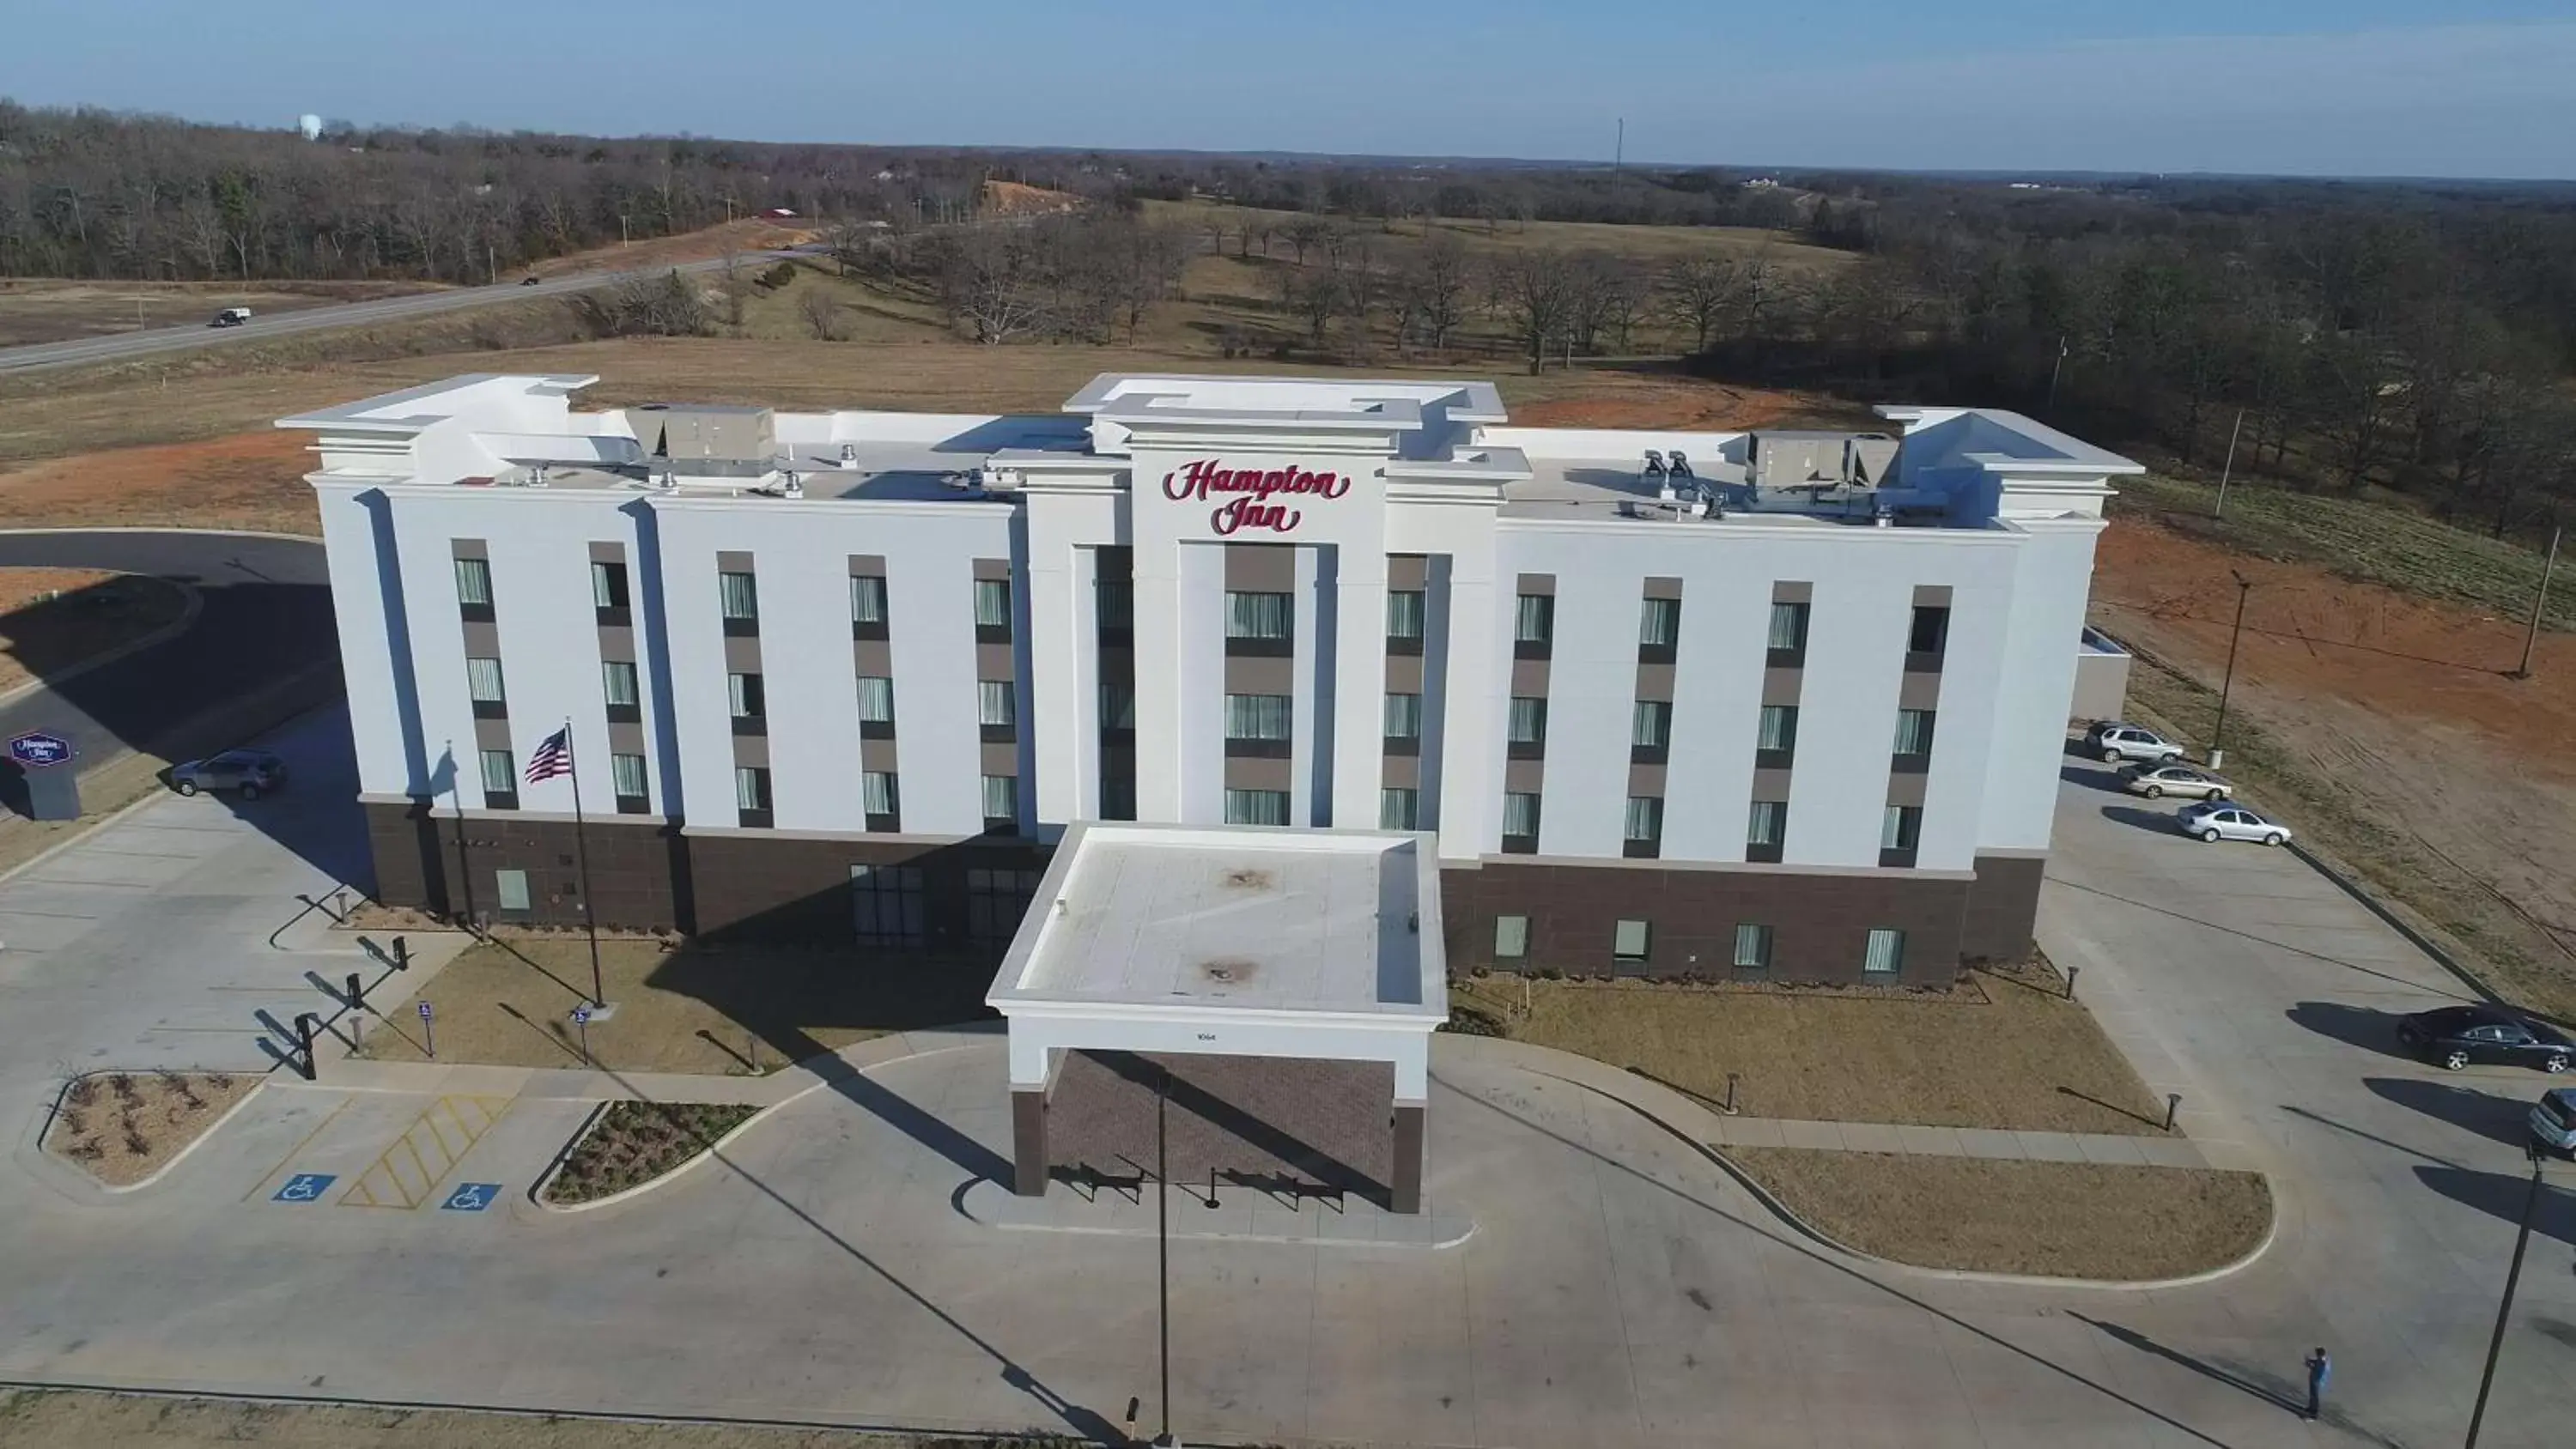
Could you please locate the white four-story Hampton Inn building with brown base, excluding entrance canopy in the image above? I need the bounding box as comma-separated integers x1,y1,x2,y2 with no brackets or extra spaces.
281,376,2138,983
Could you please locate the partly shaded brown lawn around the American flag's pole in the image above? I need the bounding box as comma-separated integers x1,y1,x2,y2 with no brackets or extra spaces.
366,934,992,1076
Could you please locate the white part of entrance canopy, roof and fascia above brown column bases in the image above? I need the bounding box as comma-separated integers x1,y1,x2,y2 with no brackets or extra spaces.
984,821,1448,1106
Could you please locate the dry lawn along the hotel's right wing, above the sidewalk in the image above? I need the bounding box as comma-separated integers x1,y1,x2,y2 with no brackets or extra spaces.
1453,965,2164,1132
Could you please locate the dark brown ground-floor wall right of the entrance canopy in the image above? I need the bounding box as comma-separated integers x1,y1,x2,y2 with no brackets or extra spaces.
1440,857,1971,985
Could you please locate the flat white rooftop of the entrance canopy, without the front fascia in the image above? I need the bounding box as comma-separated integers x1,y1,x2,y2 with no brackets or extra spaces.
987,823,1448,1032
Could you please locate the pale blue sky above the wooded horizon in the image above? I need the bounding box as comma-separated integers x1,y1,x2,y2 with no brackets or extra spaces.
15,0,2576,178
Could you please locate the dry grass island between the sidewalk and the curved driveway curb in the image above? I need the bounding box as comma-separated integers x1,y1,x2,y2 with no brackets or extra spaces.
1726,1148,2272,1279
